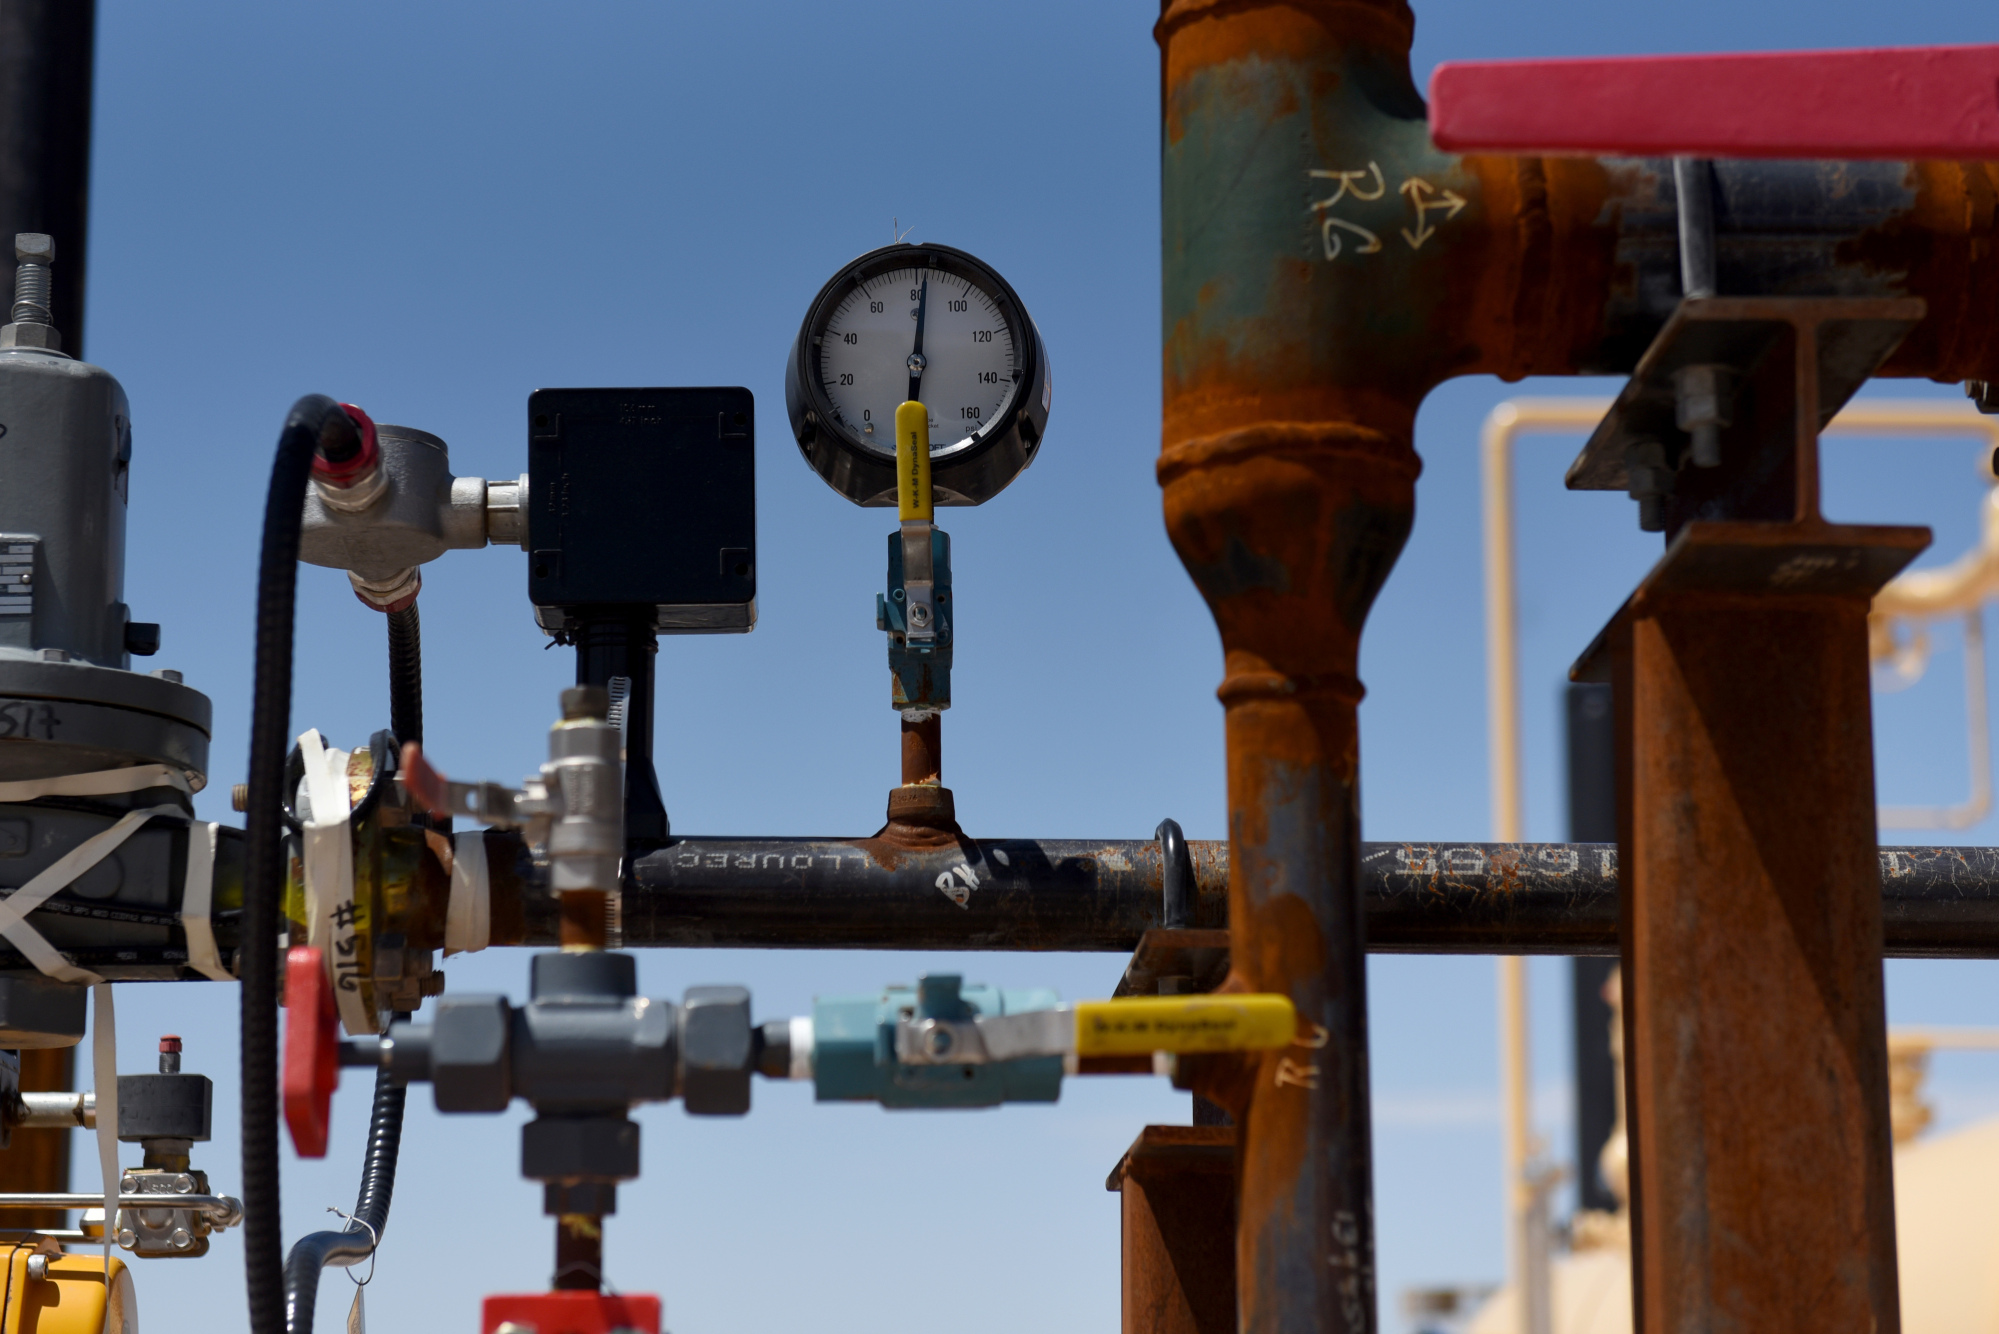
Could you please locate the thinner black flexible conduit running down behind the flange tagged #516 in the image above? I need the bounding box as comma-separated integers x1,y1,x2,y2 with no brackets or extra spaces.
284,602,424,1334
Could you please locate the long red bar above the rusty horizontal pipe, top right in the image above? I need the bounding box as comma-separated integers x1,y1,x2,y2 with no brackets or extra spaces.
1429,46,1999,160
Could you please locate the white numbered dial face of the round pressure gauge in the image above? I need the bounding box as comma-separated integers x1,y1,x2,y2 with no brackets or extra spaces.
820,268,1021,454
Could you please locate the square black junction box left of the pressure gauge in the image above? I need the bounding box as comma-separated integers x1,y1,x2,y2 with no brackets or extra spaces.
528,388,756,634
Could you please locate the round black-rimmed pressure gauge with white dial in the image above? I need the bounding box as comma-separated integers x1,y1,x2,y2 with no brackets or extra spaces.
784,244,1049,506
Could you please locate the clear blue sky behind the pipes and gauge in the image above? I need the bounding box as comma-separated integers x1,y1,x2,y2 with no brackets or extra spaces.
58,0,1999,1334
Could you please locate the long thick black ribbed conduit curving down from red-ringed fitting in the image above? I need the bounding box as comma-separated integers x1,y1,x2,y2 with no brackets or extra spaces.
238,394,362,1334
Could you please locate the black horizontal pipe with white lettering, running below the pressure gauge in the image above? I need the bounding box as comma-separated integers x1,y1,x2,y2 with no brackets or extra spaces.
503,838,1999,958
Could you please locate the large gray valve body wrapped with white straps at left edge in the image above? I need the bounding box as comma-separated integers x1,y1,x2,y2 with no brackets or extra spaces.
0,234,210,1048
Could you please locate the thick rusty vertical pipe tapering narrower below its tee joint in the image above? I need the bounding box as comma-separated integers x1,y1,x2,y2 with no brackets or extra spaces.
1157,0,1421,1334
